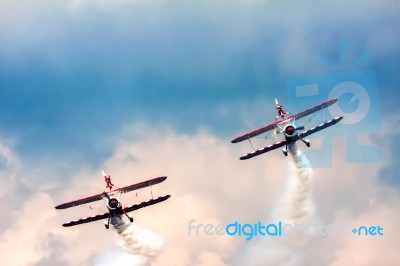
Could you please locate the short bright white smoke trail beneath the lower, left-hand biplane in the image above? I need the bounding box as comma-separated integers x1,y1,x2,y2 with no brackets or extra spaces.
97,221,164,266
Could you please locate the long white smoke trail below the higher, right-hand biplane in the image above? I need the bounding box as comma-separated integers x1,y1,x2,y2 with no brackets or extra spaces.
239,147,314,266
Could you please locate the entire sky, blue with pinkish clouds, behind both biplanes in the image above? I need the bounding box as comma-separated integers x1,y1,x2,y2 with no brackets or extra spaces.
0,0,400,266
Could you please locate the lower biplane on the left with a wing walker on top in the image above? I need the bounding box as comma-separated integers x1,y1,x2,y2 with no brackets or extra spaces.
55,171,170,229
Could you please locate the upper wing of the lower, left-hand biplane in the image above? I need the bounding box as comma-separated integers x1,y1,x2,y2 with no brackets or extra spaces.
55,176,167,209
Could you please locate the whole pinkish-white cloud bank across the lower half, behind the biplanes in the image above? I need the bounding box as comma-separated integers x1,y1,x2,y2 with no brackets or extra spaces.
0,119,399,266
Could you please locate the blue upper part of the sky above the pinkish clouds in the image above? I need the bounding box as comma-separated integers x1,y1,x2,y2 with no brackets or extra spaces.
0,1,399,167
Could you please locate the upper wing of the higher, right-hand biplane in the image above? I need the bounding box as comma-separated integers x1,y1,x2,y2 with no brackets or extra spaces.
231,98,338,143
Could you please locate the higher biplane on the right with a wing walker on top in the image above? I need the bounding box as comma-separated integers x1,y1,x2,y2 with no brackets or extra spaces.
231,98,343,160
